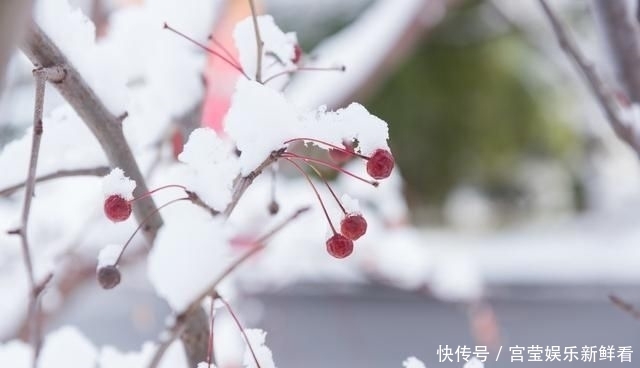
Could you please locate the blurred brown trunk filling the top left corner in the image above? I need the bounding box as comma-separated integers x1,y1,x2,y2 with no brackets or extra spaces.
0,0,32,93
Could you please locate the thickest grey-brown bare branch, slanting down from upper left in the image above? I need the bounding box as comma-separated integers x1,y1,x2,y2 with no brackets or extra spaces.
22,23,162,243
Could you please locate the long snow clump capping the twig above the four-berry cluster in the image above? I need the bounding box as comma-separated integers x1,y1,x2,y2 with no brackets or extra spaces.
225,79,389,175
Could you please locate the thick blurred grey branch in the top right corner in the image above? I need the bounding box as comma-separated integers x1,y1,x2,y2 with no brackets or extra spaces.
593,0,640,102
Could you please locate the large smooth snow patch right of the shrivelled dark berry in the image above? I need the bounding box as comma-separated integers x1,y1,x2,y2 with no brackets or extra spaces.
147,216,231,313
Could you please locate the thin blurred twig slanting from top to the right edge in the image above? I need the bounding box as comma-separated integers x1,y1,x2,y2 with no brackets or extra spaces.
539,0,640,154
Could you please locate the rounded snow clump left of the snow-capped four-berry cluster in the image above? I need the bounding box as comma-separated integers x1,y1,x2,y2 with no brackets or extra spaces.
178,128,240,211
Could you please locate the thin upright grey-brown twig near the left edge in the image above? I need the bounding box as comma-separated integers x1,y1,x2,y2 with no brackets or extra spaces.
9,66,65,367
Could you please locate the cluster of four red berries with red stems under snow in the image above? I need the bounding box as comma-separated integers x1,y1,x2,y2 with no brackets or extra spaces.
282,138,395,258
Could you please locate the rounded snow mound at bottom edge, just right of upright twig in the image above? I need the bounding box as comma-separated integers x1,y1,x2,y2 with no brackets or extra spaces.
38,326,98,368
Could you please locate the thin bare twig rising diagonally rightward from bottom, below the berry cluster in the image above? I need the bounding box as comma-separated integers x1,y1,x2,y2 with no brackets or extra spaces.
148,207,309,368
